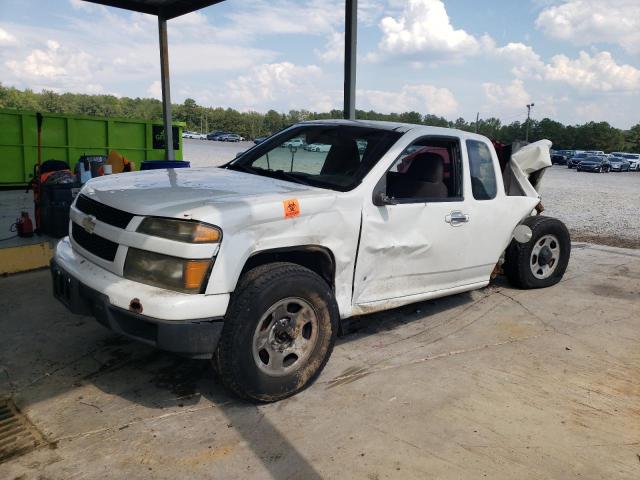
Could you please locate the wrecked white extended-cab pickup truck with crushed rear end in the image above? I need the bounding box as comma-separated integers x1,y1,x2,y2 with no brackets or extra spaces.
51,120,571,401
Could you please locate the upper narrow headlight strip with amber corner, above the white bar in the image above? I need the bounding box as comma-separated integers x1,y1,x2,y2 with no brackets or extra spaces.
137,217,222,243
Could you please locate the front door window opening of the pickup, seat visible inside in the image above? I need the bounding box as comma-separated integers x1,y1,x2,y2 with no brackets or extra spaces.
386,138,462,203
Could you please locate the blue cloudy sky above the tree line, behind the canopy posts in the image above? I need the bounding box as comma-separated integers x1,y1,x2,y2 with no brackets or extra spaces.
0,0,640,128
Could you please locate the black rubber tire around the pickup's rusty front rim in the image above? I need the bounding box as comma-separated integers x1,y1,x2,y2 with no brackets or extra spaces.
213,262,339,402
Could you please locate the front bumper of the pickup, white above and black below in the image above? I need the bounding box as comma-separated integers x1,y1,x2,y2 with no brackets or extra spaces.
51,239,228,358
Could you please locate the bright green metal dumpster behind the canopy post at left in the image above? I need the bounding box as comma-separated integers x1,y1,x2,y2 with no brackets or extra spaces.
0,109,185,187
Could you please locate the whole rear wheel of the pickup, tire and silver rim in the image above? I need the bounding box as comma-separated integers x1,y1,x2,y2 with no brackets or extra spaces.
504,215,571,289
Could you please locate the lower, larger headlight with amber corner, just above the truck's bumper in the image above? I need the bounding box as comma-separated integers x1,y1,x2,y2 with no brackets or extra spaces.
124,247,213,293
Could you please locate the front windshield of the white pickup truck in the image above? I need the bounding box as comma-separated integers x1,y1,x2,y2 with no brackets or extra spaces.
226,124,402,191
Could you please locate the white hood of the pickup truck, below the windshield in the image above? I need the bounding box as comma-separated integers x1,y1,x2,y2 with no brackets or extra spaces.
82,167,335,221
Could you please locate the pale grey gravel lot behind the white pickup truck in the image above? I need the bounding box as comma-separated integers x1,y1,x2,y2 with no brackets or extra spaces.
184,139,640,248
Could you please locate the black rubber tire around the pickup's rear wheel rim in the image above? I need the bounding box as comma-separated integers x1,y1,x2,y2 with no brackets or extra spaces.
503,215,571,289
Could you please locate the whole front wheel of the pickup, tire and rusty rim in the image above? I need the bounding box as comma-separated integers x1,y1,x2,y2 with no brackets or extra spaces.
214,263,339,402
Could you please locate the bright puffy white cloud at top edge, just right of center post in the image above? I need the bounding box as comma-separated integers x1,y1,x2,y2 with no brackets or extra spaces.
379,0,492,58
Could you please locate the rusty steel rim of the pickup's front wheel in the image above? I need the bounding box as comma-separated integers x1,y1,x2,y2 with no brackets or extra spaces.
252,297,319,377
